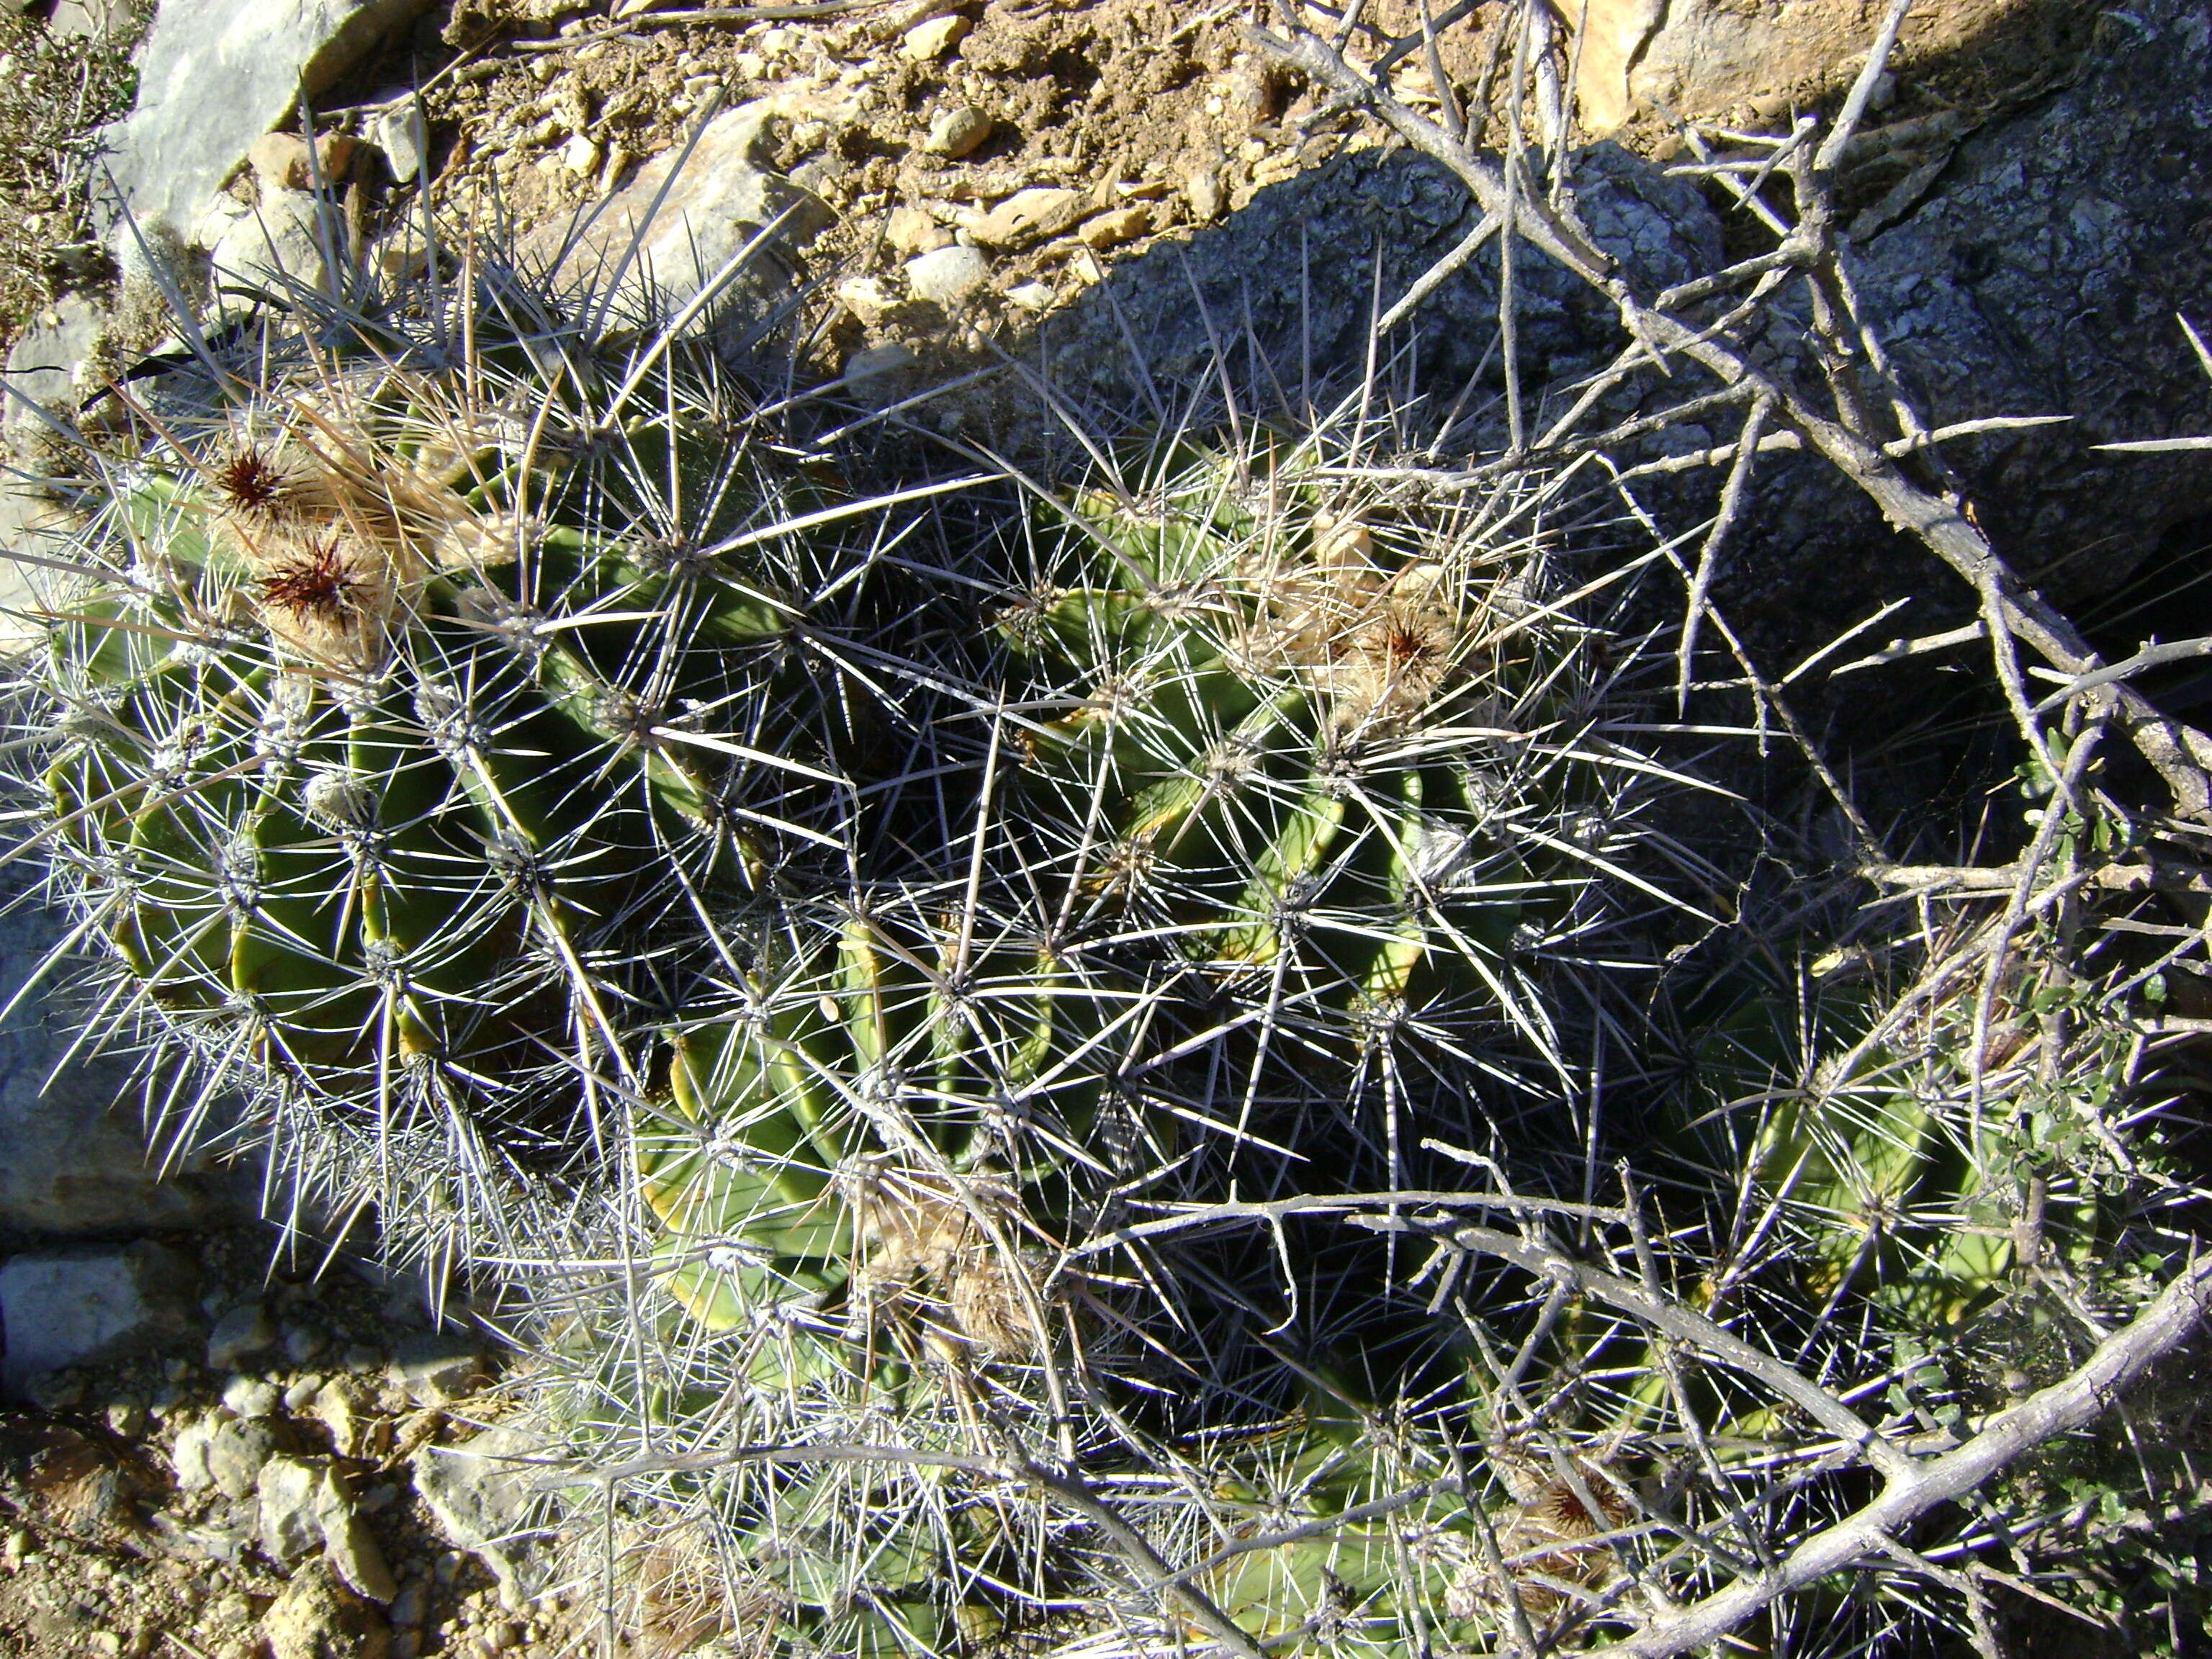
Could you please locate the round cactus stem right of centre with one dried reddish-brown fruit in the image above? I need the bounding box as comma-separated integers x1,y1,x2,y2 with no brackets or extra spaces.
997,423,1690,1186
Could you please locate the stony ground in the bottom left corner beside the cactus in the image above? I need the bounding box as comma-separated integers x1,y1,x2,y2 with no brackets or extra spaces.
0,1226,562,1659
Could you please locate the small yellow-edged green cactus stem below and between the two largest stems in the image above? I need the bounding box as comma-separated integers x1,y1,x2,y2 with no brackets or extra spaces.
635,907,1097,1376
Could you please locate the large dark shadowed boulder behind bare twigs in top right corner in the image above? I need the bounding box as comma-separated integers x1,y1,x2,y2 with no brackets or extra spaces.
1858,0,2212,606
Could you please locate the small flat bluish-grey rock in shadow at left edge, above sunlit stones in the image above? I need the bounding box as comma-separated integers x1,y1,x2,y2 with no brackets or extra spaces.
0,1238,192,1393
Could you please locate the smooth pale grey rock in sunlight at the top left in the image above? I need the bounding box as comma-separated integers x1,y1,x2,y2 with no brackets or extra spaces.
109,0,427,243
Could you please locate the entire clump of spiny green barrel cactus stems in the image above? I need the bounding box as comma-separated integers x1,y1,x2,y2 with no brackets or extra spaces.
4,166,2176,1655
